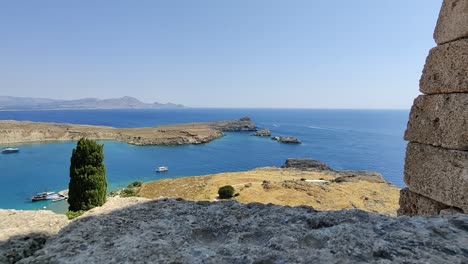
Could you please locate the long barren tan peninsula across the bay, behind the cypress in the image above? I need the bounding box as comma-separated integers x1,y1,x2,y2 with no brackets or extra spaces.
0,117,257,146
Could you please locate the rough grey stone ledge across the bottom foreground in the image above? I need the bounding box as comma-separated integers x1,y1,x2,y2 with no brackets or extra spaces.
19,199,468,263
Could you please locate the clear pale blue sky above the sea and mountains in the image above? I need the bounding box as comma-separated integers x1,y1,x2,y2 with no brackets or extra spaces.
0,0,442,109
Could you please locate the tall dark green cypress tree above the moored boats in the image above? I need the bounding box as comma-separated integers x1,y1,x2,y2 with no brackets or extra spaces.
68,138,107,211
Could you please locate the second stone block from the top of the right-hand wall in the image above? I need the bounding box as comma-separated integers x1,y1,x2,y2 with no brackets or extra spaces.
419,38,468,94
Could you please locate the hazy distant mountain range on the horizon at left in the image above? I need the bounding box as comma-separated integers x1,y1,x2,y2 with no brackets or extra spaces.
0,96,184,110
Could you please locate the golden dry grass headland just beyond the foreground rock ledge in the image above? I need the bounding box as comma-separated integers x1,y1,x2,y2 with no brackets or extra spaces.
139,168,399,215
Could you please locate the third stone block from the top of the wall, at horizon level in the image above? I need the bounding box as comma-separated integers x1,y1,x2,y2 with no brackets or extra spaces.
405,93,468,150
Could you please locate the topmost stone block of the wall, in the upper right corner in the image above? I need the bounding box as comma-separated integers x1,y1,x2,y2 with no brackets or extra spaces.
434,0,468,45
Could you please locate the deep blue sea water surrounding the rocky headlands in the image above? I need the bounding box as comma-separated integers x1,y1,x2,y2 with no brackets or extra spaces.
0,109,408,209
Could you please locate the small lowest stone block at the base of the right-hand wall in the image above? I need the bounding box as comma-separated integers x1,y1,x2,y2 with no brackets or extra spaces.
397,188,449,216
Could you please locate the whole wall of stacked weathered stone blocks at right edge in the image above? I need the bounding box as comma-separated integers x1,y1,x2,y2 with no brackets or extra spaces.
398,0,468,215
